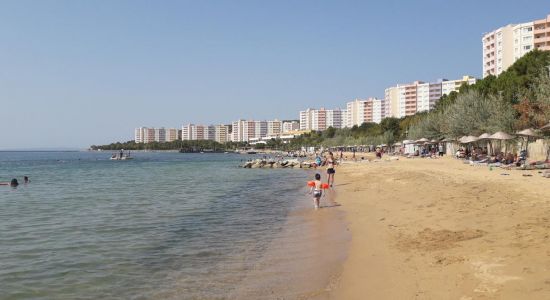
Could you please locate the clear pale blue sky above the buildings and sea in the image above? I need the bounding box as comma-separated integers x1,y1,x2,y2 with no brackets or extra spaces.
0,0,550,150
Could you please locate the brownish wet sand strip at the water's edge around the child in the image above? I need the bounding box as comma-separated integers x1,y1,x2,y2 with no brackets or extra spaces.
228,187,350,299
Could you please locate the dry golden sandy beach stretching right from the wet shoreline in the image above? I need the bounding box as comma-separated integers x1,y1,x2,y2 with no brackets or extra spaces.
328,158,550,300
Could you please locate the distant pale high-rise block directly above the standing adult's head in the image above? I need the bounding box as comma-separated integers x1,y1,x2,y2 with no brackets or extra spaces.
300,108,345,130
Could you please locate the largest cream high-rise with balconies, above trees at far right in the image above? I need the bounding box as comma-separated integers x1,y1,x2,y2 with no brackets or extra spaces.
481,15,550,78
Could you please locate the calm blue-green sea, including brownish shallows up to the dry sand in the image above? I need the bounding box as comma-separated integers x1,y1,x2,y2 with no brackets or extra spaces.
0,151,349,300
